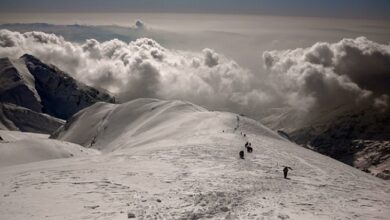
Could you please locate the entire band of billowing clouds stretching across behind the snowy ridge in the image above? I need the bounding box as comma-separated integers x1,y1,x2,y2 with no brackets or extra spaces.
0,30,390,125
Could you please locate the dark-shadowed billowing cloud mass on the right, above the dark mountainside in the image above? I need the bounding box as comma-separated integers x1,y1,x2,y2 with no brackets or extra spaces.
263,37,390,110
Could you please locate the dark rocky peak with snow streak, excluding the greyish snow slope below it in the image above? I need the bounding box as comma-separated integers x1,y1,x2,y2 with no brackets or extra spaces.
0,54,115,122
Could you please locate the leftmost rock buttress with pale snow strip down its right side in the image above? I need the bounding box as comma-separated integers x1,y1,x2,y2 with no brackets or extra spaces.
0,58,42,112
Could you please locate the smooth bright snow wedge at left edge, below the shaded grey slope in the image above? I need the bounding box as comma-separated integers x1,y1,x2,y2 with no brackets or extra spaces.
0,130,98,168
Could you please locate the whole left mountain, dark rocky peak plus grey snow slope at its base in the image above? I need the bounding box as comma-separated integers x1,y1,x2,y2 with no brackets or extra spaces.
0,54,115,133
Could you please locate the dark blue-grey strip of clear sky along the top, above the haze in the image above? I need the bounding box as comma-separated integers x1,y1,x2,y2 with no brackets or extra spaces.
0,0,390,19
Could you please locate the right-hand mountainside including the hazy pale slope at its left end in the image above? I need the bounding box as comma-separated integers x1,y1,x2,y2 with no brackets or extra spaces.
263,106,390,179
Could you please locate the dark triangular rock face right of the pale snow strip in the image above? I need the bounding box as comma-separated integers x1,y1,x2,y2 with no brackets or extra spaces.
21,54,115,119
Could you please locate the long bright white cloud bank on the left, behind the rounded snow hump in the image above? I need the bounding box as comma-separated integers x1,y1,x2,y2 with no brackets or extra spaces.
0,30,270,117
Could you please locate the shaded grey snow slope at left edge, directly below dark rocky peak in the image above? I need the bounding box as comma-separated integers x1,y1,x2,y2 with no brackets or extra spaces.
0,103,65,134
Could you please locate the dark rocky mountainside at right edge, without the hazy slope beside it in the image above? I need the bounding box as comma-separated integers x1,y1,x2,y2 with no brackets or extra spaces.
290,109,390,179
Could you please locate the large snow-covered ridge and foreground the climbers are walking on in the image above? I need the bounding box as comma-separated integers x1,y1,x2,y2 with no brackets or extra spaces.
0,99,390,219
